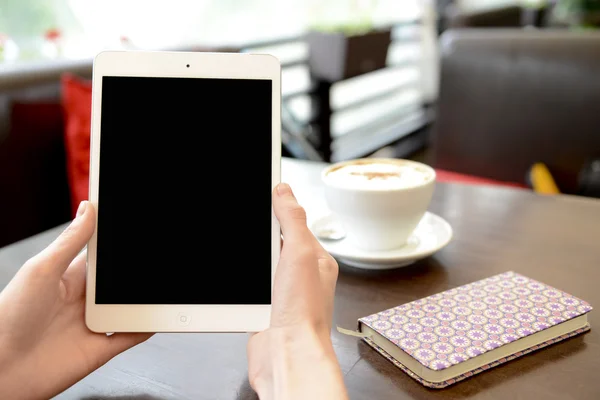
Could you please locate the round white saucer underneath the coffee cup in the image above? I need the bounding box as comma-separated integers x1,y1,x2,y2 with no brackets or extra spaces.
311,212,452,270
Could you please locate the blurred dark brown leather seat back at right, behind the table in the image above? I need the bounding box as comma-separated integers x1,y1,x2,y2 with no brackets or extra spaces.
429,28,600,194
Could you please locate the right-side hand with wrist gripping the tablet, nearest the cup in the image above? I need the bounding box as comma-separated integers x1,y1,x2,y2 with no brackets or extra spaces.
248,184,348,400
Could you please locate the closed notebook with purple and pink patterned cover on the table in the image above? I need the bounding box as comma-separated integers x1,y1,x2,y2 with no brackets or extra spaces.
358,271,592,389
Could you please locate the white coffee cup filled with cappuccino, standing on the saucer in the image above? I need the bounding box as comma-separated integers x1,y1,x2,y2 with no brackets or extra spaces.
321,158,435,251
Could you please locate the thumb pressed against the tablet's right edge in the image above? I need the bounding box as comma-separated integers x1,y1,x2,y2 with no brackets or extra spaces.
273,183,312,246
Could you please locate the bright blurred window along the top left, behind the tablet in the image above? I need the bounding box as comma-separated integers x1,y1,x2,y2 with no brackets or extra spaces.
0,0,421,62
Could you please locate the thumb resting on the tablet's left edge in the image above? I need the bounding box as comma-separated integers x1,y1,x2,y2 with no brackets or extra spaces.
28,201,96,279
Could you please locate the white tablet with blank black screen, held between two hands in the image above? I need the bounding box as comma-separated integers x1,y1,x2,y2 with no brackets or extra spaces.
85,51,281,332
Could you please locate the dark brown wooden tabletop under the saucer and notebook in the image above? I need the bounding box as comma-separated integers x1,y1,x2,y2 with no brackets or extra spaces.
0,159,600,400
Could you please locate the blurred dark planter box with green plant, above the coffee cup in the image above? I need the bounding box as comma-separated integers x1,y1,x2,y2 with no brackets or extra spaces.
306,1,391,82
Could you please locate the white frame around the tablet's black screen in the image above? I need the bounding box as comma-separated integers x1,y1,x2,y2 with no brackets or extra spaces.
85,51,281,332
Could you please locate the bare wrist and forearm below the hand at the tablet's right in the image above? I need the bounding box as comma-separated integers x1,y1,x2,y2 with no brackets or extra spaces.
253,331,348,400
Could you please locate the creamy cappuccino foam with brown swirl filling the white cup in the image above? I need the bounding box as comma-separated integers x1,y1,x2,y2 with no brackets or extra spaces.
327,161,433,190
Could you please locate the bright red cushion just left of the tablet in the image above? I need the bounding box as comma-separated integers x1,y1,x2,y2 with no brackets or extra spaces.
61,75,92,216
